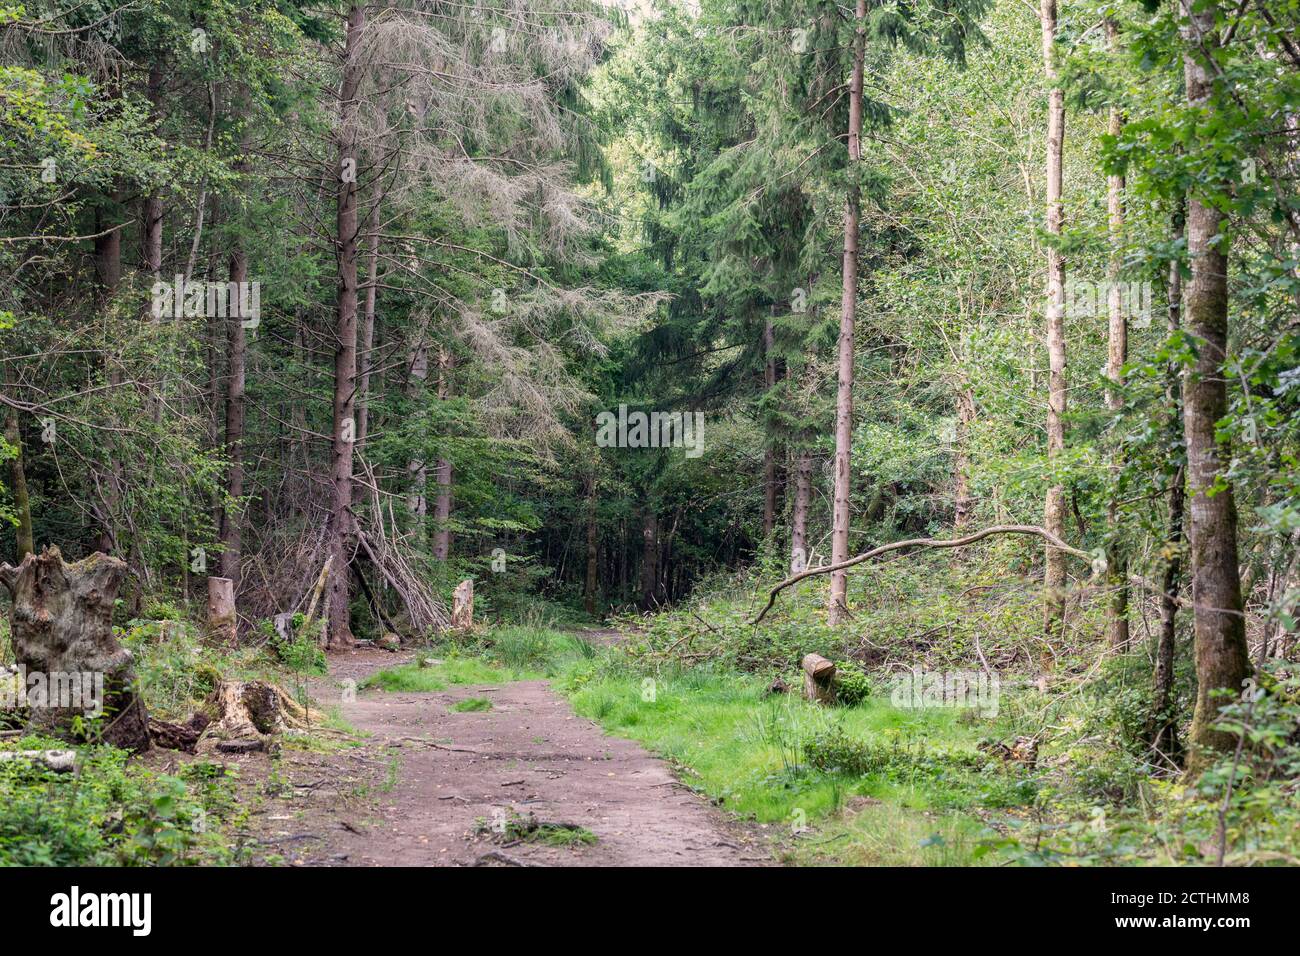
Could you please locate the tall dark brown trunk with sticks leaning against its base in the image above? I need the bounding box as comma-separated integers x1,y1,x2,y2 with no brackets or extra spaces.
328,5,365,648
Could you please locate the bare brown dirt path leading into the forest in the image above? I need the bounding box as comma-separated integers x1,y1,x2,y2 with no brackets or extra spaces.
267,650,771,866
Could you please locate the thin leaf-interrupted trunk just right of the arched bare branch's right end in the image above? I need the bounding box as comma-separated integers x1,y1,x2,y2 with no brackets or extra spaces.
1106,18,1130,650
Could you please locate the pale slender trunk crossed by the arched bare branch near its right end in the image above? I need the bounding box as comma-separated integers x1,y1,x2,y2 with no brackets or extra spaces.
1040,0,1066,641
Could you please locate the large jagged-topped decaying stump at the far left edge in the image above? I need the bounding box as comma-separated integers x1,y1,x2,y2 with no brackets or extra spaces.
0,548,150,750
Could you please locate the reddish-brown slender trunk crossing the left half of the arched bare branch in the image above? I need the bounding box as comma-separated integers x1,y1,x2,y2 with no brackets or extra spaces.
827,0,867,624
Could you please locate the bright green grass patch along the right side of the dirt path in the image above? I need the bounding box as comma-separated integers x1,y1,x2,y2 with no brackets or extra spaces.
571,669,1032,864
